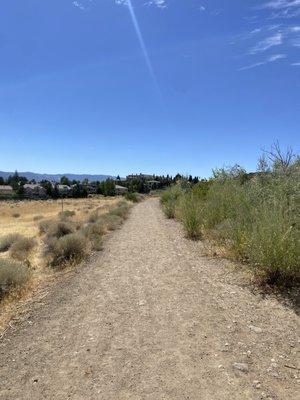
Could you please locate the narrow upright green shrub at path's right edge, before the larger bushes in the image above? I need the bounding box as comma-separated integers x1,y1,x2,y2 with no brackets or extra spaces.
178,193,202,240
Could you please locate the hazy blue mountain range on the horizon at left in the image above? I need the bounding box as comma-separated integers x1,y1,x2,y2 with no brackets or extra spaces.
0,171,115,182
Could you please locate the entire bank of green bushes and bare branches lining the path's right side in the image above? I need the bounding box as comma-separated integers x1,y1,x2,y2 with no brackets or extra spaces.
161,145,300,284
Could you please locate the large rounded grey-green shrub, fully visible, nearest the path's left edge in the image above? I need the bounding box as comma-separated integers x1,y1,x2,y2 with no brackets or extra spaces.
46,233,89,266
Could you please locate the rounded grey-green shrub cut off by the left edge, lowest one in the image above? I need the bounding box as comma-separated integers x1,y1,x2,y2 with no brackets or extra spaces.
0,259,29,298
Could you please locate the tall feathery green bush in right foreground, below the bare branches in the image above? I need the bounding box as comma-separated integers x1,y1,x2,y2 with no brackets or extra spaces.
202,167,300,282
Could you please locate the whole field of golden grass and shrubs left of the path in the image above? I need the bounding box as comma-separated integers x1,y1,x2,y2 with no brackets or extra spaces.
0,197,131,327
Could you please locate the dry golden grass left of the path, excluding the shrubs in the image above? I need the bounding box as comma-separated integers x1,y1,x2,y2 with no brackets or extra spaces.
0,196,119,332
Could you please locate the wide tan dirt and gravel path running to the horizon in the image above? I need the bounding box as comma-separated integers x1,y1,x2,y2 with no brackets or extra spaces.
0,199,300,400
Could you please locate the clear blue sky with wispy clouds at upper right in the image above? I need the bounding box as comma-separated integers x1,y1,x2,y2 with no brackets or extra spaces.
0,0,300,176
